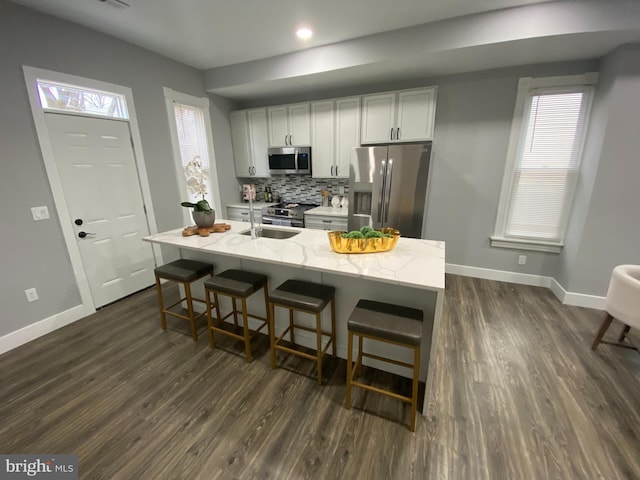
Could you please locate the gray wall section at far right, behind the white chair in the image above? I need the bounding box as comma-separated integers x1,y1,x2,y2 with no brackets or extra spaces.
559,45,640,295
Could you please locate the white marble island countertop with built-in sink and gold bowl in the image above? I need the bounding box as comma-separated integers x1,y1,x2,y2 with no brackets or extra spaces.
144,220,445,292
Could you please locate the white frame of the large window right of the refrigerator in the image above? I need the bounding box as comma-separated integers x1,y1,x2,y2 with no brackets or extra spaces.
490,72,598,253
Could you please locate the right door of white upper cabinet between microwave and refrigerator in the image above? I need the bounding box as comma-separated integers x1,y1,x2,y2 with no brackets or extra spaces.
336,97,360,178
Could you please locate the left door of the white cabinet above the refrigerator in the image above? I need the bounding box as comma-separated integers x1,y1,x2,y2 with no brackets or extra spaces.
360,93,396,144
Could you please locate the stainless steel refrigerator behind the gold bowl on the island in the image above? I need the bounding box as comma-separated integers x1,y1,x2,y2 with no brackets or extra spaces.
348,143,431,238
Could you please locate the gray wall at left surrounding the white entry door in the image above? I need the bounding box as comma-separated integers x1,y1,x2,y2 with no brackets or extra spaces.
0,0,208,336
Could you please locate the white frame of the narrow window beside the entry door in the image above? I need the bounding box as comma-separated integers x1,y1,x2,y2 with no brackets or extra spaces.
163,87,224,225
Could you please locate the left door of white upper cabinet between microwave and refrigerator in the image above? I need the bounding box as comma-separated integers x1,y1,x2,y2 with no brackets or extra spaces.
311,100,336,178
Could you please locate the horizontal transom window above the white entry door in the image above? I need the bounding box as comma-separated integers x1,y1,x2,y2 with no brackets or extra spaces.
37,80,129,119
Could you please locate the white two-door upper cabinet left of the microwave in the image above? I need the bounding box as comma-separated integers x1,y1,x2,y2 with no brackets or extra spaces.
230,108,269,178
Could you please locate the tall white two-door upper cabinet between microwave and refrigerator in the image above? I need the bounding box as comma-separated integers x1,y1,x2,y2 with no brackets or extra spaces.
311,97,360,178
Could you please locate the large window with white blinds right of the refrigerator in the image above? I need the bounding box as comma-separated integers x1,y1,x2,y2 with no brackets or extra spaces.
491,74,596,253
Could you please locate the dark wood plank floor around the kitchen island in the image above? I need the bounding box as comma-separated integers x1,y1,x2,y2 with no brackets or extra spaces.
0,275,640,480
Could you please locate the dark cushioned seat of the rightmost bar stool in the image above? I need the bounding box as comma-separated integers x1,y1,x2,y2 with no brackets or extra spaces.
347,300,422,345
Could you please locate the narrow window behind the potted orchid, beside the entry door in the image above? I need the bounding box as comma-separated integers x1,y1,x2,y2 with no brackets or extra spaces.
164,88,222,224
